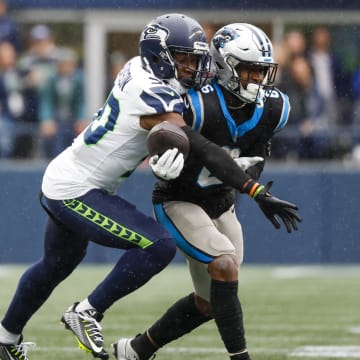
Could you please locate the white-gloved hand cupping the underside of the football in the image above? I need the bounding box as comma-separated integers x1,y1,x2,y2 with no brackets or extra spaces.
149,148,184,180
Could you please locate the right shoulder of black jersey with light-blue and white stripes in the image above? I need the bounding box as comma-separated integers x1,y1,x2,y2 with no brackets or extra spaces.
266,88,291,132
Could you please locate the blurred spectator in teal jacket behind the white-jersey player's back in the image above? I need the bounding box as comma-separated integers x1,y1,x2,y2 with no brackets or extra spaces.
39,48,88,159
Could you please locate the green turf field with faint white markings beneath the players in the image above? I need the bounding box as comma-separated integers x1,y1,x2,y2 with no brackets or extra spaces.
0,265,360,360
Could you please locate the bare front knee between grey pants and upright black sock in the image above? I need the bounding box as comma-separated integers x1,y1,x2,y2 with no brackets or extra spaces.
208,255,239,281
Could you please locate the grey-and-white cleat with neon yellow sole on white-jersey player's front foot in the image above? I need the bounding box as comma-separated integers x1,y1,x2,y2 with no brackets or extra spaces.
61,303,109,360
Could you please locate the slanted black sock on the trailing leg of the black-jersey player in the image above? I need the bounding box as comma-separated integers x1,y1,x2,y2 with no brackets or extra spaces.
131,294,212,360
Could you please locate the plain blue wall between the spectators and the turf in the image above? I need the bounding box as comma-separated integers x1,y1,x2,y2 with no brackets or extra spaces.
0,164,360,264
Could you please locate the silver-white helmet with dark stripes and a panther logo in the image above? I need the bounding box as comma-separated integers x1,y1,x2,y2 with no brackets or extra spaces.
210,23,278,103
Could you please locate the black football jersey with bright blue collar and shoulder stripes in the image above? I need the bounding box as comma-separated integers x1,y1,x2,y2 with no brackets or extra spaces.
153,82,290,218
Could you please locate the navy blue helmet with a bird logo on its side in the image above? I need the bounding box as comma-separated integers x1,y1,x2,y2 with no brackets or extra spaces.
139,13,210,93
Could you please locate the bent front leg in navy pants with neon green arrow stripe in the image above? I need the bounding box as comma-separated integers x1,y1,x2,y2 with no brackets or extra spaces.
52,190,176,313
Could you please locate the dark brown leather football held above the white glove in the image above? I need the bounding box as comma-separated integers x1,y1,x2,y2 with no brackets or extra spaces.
146,121,190,159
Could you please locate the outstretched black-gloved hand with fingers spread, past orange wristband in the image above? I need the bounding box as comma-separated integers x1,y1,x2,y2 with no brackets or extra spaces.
254,181,302,233
